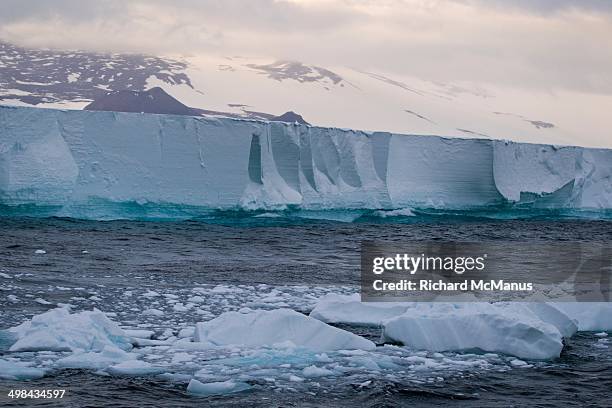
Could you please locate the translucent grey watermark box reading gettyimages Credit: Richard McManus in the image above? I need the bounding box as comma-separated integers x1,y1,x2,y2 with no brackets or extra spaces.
361,241,612,302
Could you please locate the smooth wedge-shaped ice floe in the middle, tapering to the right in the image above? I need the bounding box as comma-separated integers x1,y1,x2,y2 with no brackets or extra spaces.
195,309,376,351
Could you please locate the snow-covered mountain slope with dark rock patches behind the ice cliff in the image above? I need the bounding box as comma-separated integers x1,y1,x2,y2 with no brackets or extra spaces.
0,43,612,147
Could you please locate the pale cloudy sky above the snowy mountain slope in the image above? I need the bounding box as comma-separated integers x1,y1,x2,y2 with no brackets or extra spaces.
0,0,612,95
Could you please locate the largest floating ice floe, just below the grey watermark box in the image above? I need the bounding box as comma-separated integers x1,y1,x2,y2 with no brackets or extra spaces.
310,294,577,359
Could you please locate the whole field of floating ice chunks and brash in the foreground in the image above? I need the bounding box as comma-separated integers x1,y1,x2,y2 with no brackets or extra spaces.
0,273,612,396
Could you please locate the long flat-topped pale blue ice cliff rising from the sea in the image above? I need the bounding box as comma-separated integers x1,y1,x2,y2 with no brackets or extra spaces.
0,106,612,214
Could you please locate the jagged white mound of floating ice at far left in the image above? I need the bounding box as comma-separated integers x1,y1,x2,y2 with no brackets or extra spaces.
8,308,132,352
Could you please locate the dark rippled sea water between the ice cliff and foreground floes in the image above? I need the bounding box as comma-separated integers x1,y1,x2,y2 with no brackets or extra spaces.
0,214,612,407
